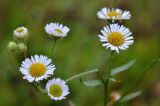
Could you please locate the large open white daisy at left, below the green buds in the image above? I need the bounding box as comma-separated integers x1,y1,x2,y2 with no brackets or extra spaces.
20,55,56,82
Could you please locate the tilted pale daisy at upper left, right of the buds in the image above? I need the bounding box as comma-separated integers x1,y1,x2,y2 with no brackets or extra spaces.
45,23,70,37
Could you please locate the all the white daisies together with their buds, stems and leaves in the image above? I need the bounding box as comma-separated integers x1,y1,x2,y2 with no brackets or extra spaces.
7,0,159,106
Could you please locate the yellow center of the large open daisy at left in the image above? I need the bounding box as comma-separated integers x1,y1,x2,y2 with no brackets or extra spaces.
29,63,46,77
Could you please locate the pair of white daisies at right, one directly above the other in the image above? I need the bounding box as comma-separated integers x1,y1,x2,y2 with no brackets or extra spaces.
97,8,134,53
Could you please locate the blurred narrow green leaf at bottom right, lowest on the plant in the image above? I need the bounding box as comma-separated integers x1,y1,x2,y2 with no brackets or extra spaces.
120,91,142,102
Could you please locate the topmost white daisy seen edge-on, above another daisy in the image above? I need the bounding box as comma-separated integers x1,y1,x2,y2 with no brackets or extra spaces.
97,8,131,22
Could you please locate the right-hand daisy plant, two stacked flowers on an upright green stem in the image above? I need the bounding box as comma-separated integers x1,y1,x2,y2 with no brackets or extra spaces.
97,4,134,106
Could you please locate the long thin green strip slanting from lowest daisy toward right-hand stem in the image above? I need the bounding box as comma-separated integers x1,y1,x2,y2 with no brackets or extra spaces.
66,69,98,82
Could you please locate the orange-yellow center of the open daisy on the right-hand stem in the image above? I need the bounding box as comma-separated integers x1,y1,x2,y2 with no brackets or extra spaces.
107,32,125,46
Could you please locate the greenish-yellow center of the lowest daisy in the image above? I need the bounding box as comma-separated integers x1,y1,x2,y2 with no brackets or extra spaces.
49,84,62,97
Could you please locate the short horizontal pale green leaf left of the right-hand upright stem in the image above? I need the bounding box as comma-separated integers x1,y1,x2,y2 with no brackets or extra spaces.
80,79,103,87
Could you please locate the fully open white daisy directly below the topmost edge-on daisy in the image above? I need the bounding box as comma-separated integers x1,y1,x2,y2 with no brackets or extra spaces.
98,24,134,53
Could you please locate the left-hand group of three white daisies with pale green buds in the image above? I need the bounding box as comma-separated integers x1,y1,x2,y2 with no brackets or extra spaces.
8,23,70,100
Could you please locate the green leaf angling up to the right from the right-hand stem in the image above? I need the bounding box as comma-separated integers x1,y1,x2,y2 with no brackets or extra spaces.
111,59,136,76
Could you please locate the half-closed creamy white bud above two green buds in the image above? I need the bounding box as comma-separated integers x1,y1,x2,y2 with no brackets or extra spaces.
14,27,28,40
